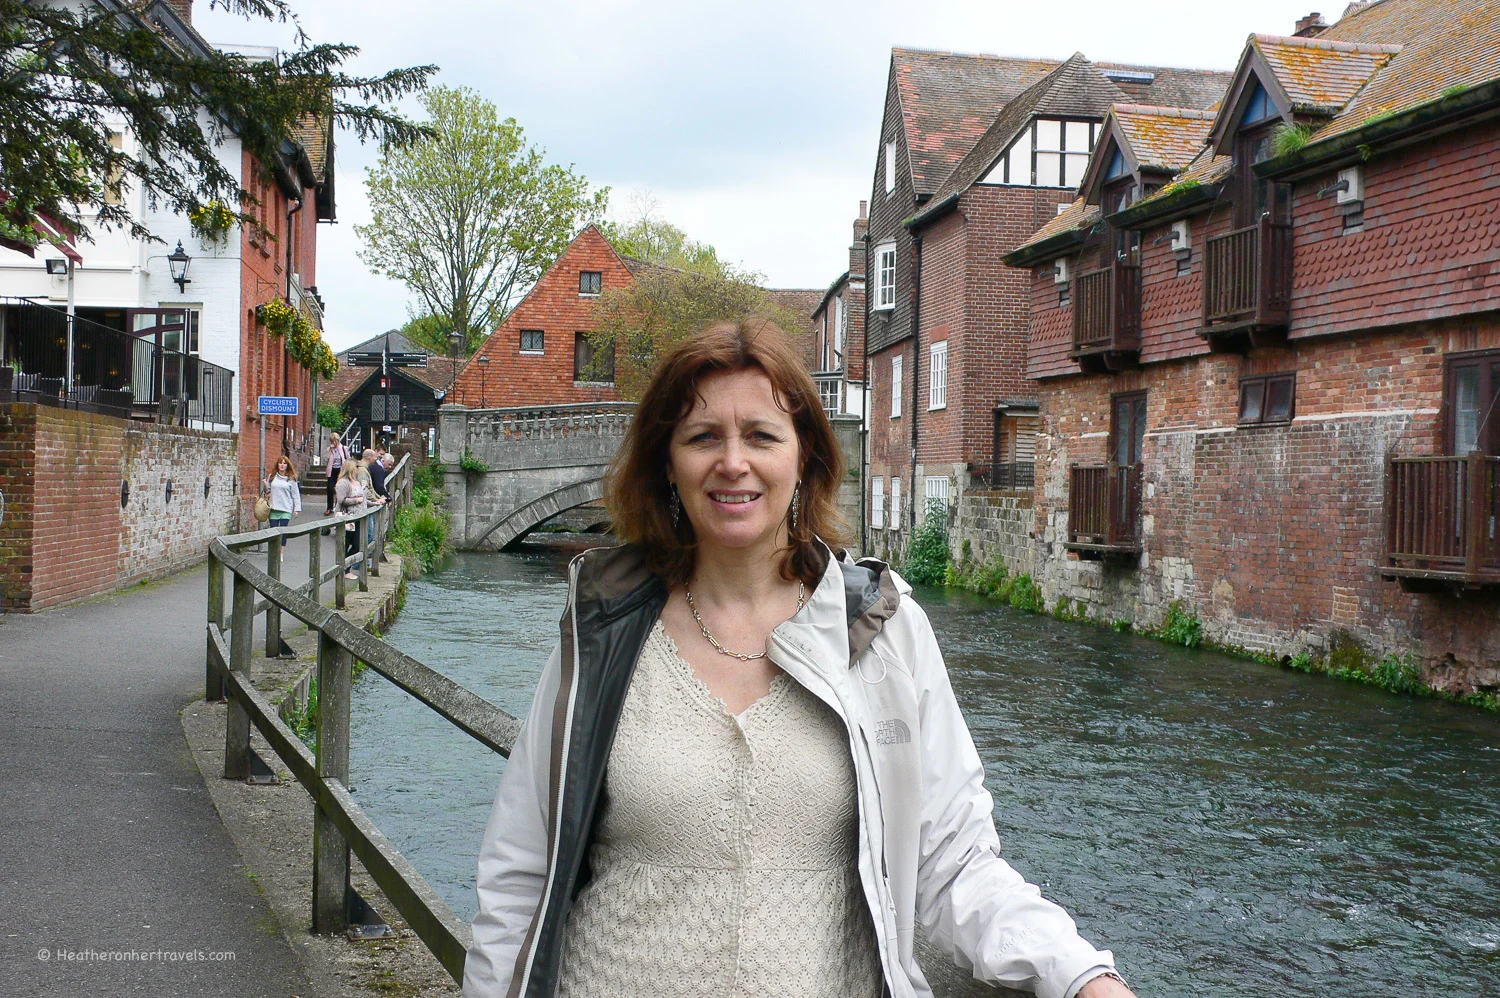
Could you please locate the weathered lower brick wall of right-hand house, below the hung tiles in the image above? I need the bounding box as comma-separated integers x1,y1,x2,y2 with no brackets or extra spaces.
1034,317,1500,689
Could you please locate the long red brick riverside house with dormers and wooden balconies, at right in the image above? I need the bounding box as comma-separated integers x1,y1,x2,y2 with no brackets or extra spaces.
1007,0,1500,689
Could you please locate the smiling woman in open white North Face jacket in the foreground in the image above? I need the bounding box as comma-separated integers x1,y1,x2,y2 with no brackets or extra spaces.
464,320,1131,998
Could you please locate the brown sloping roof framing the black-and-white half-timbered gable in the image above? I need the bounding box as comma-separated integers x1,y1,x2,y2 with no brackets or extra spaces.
917,53,1229,222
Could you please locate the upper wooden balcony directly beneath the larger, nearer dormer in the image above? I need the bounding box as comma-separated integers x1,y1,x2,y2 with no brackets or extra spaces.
1202,215,1292,351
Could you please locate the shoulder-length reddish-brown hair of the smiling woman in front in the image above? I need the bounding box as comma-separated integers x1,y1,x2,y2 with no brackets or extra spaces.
605,315,846,588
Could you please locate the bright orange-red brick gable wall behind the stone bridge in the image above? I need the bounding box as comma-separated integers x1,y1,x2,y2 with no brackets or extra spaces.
449,225,632,408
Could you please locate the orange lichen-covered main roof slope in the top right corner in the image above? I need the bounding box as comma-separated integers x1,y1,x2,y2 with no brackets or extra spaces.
1313,0,1500,141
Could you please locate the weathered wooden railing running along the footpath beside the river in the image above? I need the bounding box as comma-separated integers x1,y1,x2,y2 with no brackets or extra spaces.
206,456,521,981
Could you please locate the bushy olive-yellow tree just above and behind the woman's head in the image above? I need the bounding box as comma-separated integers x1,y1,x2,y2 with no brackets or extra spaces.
585,267,809,399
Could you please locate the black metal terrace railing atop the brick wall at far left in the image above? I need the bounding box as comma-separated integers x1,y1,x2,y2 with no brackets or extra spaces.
0,292,234,428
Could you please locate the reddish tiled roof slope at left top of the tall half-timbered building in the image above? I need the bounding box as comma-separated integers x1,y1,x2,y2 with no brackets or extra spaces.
891,48,1061,194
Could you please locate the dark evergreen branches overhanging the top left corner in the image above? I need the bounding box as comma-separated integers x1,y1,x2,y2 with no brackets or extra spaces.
0,0,437,246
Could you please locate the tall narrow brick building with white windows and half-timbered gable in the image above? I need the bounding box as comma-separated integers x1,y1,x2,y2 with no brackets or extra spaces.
866,48,1227,549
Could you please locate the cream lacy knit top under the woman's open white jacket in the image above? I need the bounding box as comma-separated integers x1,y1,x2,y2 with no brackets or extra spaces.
558,621,882,998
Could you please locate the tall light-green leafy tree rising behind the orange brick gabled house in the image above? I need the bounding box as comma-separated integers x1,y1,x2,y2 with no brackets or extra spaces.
356,87,609,349
